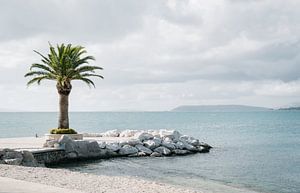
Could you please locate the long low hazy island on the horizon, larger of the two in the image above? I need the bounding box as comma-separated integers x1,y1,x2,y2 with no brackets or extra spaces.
172,105,272,112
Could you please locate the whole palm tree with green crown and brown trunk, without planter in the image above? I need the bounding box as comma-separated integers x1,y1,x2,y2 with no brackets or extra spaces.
25,43,103,129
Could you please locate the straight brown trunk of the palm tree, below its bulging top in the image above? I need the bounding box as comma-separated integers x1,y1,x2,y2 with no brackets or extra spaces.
58,94,69,129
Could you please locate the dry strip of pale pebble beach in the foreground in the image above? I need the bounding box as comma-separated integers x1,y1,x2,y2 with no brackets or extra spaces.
0,165,199,193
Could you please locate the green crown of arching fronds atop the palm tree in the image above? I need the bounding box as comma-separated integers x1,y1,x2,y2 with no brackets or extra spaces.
25,43,103,87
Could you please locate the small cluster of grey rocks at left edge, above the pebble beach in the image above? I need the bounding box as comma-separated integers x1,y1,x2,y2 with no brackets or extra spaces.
0,148,39,167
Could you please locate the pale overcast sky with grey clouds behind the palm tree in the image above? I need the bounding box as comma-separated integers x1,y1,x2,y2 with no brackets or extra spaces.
0,0,300,111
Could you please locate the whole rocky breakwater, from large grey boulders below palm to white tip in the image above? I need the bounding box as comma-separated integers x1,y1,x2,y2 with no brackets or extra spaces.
45,130,211,159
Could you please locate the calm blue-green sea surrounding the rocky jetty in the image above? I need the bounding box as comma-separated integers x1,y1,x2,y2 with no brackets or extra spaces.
0,111,300,193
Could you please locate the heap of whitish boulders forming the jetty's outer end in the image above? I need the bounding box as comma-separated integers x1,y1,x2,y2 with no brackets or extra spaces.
98,130,211,157
